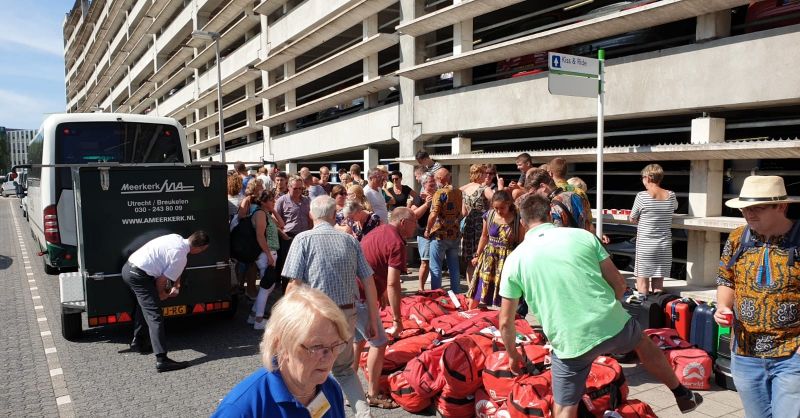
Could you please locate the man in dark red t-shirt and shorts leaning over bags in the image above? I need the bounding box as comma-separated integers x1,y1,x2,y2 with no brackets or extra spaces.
354,207,417,408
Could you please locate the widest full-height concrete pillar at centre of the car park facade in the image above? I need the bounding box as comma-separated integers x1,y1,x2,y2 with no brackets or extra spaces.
394,0,425,189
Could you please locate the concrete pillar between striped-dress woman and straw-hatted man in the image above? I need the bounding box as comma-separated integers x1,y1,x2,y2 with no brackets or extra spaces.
686,117,725,286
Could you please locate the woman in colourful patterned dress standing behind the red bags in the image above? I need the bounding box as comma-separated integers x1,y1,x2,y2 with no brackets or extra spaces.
467,190,525,309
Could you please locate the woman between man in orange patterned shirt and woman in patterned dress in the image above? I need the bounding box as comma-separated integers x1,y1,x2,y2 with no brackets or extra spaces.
460,164,494,290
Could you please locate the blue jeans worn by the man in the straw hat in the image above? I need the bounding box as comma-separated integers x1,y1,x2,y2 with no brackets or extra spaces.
731,353,800,418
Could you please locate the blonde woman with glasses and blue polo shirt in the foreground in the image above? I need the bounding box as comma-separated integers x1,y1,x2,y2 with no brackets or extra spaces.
212,286,351,418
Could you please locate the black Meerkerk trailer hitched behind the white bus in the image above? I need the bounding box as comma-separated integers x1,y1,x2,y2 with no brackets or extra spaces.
59,162,237,340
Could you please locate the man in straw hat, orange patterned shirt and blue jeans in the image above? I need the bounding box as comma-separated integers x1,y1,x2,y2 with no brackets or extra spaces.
714,176,800,417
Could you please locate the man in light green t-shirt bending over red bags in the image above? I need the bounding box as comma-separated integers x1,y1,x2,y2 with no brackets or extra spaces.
500,193,703,417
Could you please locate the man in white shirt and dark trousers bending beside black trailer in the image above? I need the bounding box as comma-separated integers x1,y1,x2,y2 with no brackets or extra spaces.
122,231,209,373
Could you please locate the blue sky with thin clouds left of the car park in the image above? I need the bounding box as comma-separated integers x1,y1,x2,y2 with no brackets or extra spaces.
0,0,75,129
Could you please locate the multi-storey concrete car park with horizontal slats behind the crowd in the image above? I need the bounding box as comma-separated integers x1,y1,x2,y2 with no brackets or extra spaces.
63,0,800,283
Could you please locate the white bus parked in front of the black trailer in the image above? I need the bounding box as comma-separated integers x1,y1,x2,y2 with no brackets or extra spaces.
27,113,190,274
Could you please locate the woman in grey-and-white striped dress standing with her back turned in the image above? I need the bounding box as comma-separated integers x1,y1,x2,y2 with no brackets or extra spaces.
631,164,678,295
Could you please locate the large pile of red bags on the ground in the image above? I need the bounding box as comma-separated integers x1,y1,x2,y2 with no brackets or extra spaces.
360,290,656,418
